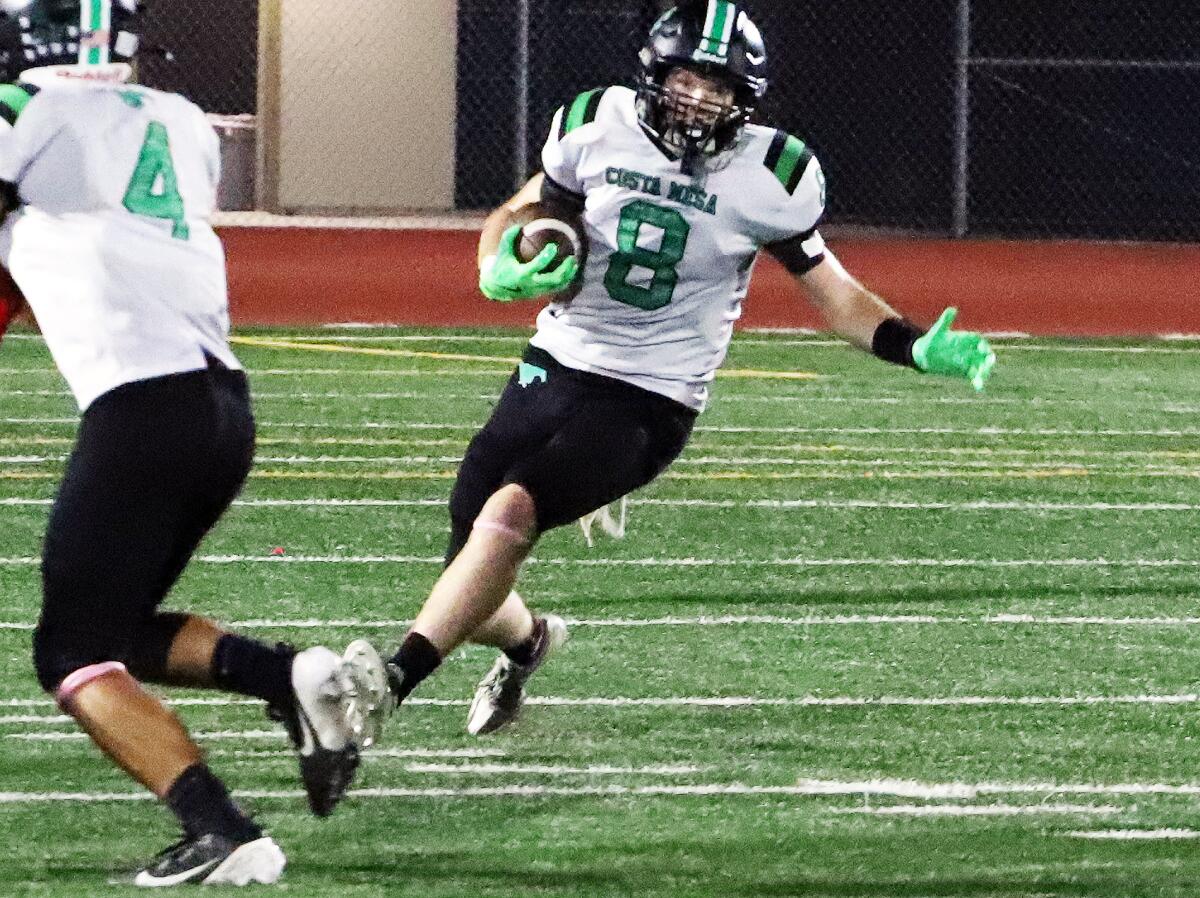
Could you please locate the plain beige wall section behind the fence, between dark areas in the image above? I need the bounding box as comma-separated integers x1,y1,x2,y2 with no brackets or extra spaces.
259,0,457,212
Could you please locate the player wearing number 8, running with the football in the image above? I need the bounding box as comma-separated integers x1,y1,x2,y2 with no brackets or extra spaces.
348,0,995,732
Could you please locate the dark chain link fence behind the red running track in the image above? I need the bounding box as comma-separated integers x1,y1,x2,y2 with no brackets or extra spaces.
136,0,1200,241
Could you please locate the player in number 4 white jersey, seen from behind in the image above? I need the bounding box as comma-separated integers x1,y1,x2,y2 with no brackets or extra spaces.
0,0,367,886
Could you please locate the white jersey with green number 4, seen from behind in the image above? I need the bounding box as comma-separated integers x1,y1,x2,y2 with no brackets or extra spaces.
0,82,240,409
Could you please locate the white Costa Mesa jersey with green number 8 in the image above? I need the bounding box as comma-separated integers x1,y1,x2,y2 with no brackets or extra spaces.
532,88,824,409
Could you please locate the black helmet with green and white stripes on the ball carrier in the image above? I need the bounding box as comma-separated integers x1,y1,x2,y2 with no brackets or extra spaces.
637,0,767,174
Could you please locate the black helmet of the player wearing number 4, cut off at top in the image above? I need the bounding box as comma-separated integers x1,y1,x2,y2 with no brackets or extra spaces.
0,0,138,80
